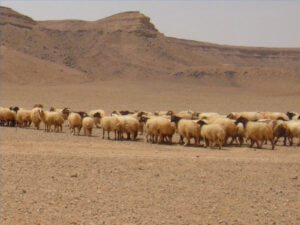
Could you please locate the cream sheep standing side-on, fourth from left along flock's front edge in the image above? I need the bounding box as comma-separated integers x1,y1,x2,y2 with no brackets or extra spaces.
38,109,64,132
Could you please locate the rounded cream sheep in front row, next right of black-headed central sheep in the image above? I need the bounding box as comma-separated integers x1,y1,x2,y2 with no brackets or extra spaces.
197,120,225,150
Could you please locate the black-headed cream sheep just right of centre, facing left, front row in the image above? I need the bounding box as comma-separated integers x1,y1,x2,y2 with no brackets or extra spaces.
171,115,200,145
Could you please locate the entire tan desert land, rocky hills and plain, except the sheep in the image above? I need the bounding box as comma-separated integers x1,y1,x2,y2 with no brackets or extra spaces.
0,6,300,225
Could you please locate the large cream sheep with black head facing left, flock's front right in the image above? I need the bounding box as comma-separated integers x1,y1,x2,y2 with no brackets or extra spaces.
235,117,275,150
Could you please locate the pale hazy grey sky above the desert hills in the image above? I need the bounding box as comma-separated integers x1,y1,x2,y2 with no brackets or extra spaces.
0,0,300,47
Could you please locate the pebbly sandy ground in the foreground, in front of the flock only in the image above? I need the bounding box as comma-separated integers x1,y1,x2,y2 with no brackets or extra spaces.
1,124,300,224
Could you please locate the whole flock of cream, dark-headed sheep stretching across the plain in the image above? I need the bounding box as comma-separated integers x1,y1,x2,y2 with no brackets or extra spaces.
0,104,300,149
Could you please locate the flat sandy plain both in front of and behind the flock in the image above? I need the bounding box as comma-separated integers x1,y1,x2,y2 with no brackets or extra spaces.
0,82,300,225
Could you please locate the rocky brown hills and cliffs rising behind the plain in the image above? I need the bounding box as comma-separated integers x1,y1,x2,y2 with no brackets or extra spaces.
0,7,300,86
